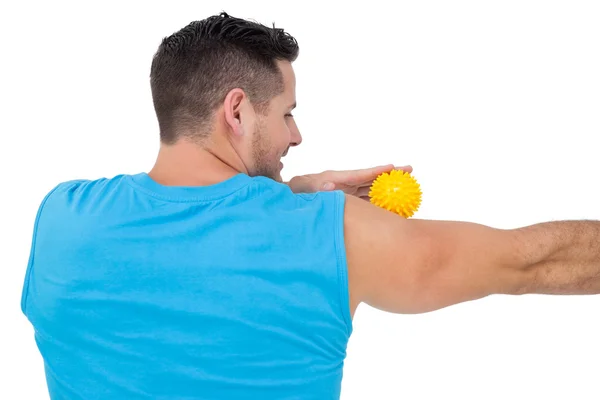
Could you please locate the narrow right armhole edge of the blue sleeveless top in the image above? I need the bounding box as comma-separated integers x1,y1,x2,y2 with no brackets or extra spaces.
333,191,353,337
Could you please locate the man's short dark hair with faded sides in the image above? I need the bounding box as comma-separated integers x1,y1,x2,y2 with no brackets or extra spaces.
150,12,299,144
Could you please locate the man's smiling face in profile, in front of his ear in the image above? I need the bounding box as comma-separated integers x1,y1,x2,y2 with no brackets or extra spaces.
251,62,302,182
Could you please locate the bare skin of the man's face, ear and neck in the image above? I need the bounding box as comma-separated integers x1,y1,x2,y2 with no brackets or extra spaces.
149,62,302,186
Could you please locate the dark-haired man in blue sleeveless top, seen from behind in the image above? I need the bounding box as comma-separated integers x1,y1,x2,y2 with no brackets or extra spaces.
22,13,600,400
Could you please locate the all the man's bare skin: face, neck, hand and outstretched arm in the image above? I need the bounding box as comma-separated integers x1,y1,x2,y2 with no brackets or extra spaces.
149,62,600,322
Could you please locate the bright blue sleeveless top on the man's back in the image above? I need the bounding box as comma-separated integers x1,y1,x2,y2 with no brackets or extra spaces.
21,173,352,400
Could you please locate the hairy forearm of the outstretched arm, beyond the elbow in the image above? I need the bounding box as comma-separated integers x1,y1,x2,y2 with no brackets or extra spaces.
514,221,600,294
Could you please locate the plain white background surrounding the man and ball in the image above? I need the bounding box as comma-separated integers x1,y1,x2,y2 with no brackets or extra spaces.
0,0,600,400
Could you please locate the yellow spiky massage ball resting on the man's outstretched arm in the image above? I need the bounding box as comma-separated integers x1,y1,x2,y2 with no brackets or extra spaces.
369,170,422,218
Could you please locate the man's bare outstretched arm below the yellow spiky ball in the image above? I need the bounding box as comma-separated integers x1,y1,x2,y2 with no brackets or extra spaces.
345,196,600,313
